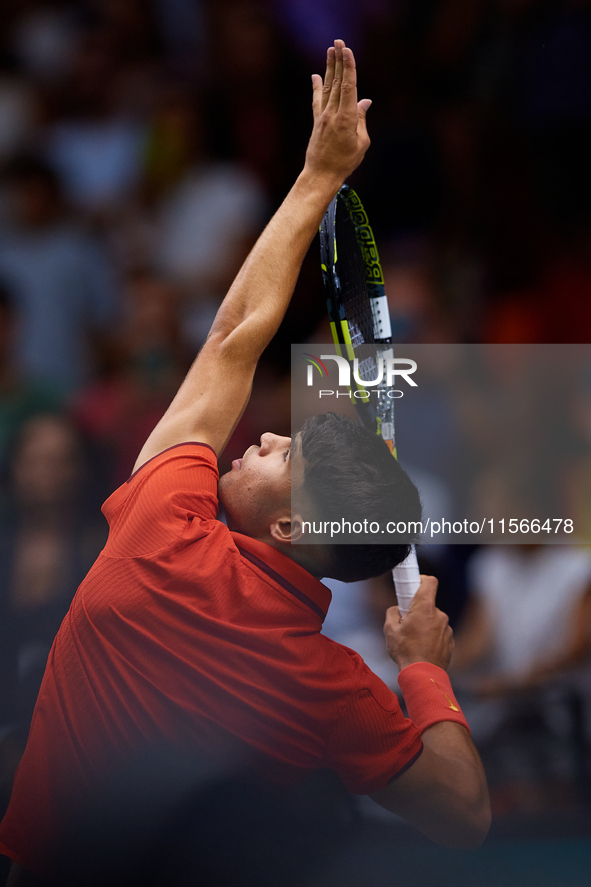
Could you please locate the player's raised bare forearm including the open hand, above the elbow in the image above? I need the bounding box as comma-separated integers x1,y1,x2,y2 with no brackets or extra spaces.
204,40,371,360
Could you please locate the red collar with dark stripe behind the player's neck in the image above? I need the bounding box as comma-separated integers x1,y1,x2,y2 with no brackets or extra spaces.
232,533,332,622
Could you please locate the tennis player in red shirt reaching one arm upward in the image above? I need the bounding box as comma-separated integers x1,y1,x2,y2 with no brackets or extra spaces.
0,40,489,884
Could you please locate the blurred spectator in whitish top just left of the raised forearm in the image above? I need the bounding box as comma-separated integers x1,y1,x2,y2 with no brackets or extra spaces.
148,96,268,345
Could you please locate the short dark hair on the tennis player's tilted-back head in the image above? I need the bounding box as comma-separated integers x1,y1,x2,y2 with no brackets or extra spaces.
296,413,422,582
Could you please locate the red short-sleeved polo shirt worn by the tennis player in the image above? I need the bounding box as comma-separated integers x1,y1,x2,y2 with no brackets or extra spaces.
0,443,422,873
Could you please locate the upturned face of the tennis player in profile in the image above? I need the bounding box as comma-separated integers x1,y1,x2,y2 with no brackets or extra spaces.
218,432,301,539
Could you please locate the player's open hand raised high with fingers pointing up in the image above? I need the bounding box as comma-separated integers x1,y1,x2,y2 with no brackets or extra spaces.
305,40,371,190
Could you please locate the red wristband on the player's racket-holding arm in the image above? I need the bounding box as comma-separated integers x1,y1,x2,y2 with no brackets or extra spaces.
398,662,470,733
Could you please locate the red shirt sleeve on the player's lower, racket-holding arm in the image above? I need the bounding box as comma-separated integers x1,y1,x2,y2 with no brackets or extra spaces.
325,664,423,795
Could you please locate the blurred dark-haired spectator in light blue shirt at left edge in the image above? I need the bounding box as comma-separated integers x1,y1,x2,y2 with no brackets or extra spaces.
0,158,115,396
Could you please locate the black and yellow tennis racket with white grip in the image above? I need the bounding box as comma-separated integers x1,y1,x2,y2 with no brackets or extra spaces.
320,185,420,616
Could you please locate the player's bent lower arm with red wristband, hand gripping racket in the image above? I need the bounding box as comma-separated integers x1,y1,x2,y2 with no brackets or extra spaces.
372,576,490,848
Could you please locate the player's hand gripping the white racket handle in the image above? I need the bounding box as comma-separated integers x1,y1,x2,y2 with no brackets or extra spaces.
384,576,454,669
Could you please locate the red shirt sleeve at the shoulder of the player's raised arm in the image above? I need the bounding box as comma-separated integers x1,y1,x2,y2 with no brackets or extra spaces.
102,443,219,557
